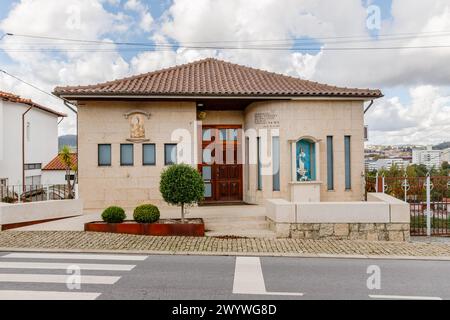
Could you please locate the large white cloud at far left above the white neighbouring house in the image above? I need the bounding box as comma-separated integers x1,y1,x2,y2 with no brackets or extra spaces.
0,0,130,133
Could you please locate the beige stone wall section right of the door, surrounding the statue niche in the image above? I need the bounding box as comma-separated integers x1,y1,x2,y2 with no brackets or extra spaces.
244,100,364,203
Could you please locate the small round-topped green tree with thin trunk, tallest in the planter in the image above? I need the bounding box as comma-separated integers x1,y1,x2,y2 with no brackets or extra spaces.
159,164,205,223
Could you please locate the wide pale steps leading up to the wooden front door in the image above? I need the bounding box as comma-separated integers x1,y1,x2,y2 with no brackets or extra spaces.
204,216,275,238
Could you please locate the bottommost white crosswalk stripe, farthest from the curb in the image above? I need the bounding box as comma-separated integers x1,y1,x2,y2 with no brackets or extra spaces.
0,290,100,300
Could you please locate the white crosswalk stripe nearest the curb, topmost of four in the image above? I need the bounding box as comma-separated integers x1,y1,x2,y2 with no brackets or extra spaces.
2,252,148,261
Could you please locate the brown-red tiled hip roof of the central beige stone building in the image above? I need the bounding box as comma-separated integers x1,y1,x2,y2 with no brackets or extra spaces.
54,58,383,98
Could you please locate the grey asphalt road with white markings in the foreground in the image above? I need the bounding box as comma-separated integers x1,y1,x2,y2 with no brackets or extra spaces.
0,252,450,300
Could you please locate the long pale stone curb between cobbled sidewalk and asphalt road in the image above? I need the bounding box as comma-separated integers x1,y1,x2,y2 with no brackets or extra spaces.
0,247,450,261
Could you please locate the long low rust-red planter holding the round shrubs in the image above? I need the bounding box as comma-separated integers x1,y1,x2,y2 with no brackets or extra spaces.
84,219,205,237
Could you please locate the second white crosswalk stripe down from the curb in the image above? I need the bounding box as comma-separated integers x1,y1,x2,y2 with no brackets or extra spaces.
0,261,135,271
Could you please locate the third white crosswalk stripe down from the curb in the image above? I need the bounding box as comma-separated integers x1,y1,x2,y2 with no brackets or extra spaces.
0,273,120,284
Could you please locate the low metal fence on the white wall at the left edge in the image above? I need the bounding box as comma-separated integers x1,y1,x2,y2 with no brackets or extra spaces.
0,184,74,203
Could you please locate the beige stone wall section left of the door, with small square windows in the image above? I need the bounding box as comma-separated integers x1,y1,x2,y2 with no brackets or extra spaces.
78,101,197,210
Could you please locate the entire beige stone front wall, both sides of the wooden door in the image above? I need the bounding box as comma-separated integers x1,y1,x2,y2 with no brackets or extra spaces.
78,100,364,209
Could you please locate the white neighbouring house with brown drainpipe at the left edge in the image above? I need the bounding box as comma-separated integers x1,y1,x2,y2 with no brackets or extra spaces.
0,91,66,186
